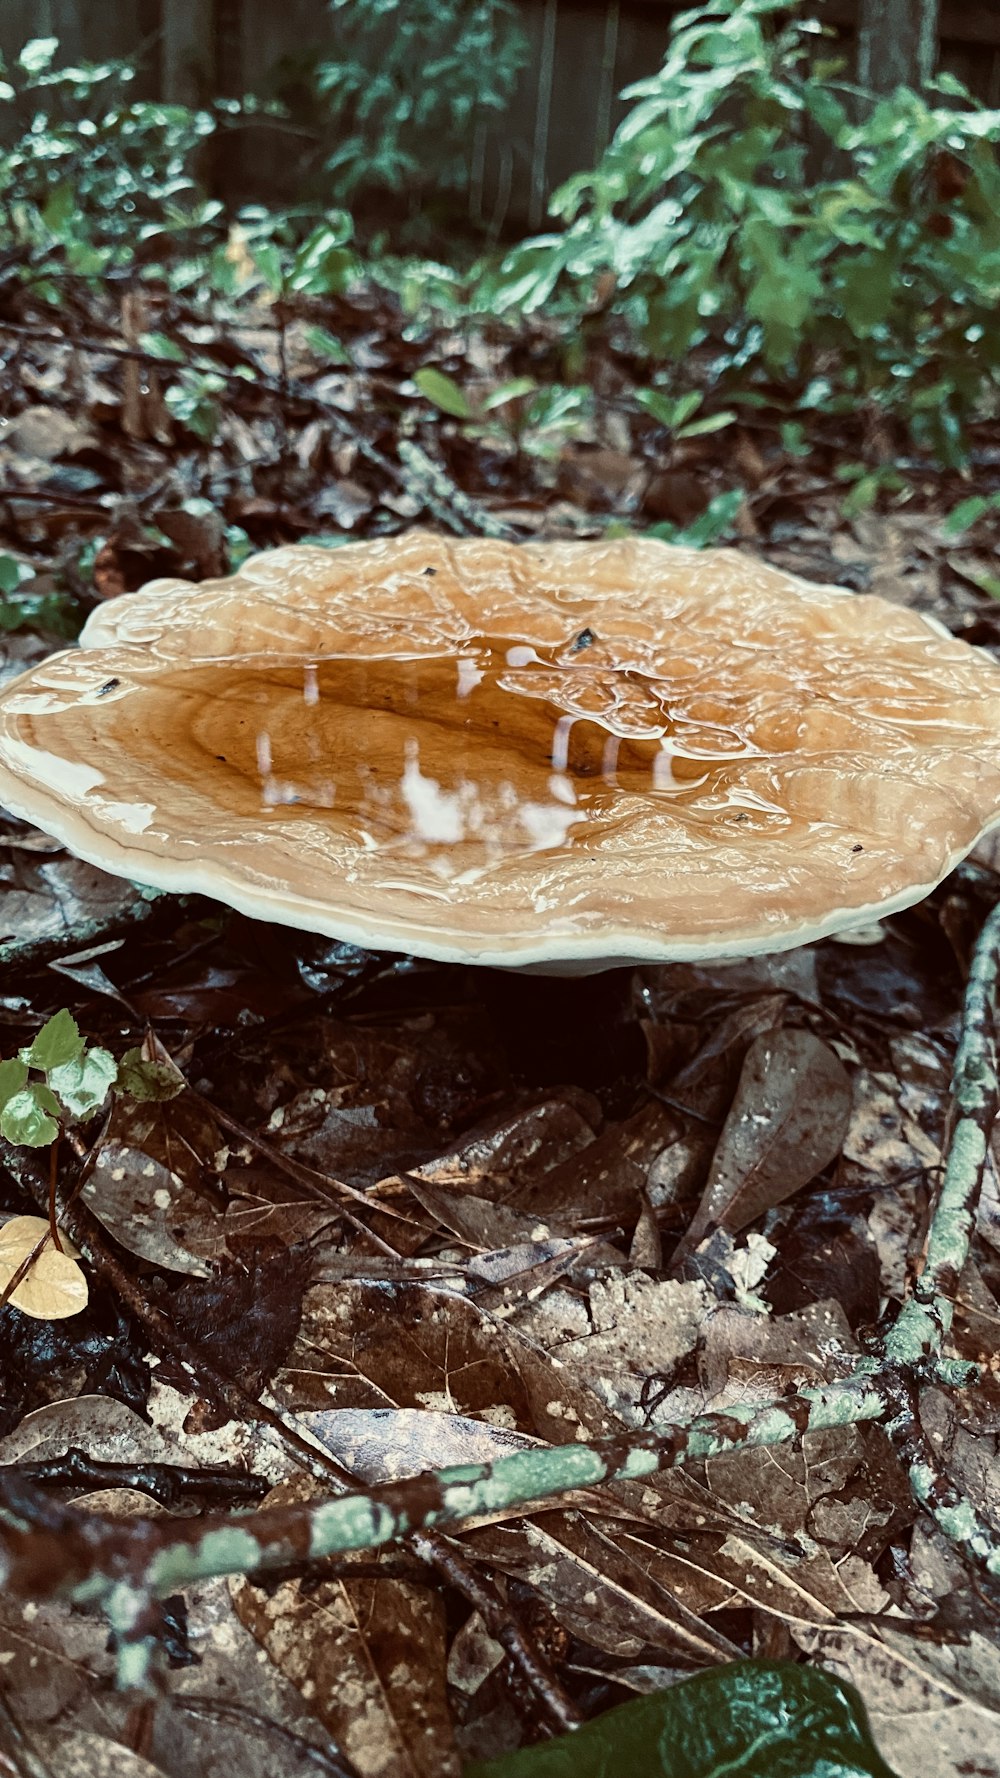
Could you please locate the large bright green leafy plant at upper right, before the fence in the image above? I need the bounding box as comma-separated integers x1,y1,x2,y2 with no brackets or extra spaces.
488,0,1000,464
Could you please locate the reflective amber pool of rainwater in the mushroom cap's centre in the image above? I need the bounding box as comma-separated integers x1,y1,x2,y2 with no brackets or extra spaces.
171,633,790,869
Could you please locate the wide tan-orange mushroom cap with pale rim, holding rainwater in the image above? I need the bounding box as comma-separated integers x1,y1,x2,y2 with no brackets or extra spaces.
0,532,1000,971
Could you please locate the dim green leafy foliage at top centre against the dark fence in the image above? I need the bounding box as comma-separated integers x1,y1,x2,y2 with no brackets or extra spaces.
315,0,525,201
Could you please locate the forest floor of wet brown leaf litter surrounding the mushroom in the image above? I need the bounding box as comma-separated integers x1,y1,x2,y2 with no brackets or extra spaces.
0,280,1000,1778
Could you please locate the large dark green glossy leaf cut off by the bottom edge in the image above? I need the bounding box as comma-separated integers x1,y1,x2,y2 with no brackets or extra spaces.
464,1661,893,1778
